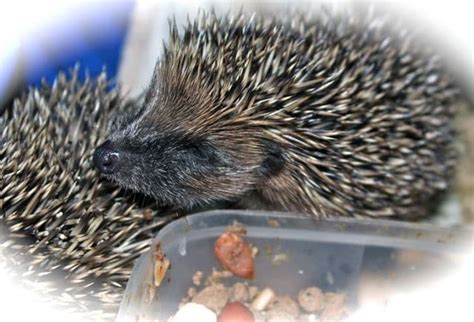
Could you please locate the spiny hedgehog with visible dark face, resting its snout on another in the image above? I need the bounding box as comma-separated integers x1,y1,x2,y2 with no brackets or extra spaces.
94,11,457,220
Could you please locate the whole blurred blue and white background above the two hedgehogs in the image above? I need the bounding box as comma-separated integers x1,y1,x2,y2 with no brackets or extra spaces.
0,0,474,106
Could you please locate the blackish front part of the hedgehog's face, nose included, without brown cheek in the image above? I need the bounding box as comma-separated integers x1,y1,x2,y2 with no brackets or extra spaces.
94,123,236,206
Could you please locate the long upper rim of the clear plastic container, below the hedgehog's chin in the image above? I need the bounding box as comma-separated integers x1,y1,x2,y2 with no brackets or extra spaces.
154,209,474,252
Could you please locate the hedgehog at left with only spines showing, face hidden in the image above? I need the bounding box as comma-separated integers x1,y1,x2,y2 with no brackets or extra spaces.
0,68,181,321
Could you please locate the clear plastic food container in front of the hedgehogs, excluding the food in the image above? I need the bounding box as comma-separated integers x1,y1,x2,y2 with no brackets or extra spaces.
118,210,472,321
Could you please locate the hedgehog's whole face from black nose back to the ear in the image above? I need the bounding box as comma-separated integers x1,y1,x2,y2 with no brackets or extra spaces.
93,102,284,207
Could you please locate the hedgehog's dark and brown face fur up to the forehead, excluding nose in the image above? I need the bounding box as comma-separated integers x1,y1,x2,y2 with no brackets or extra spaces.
95,63,282,207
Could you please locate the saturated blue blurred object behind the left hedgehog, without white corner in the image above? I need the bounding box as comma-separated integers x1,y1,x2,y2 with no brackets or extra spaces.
25,1,134,85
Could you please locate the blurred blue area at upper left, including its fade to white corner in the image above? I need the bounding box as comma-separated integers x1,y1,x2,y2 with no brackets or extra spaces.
0,0,134,109
